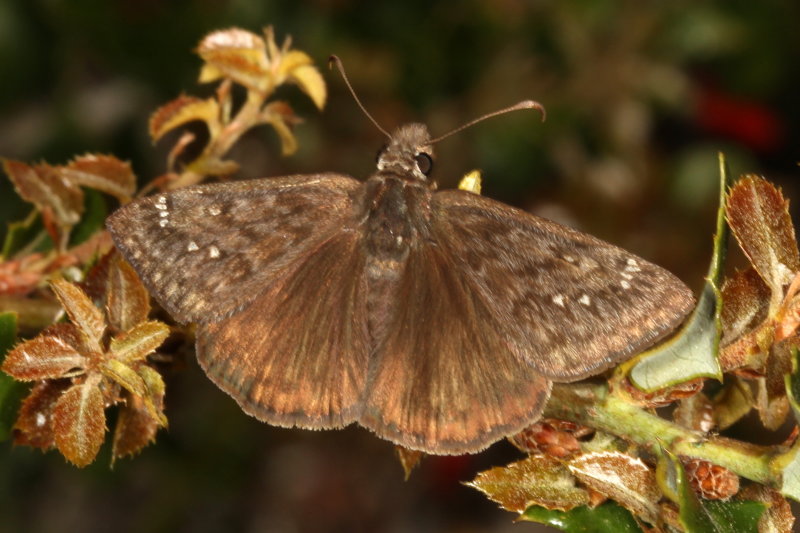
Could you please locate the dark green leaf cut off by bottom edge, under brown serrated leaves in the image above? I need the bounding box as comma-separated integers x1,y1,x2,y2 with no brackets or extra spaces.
520,502,642,533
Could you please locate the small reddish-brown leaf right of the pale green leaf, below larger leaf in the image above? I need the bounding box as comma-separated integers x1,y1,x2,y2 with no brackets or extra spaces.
721,267,770,346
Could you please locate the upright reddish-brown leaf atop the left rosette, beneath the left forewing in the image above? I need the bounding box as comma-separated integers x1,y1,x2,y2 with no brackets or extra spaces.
106,254,150,331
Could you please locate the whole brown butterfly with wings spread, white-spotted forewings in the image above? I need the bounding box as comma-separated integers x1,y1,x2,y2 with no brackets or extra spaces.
107,72,693,454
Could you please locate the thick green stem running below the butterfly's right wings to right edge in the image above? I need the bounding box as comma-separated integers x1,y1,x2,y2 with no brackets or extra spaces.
545,383,785,486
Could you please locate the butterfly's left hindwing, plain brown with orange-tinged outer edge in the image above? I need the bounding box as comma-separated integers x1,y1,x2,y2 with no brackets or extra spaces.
197,221,369,429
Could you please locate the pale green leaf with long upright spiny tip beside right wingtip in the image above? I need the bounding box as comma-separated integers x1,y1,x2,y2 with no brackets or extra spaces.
630,154,731,392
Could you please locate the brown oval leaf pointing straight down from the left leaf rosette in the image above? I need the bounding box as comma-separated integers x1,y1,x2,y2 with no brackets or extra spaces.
53,375,106,467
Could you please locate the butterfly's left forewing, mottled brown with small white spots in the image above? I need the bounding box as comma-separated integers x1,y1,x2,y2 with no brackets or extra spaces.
107,174,361,323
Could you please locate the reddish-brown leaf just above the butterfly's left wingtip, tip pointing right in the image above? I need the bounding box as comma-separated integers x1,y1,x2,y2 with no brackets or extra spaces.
59,154,136,202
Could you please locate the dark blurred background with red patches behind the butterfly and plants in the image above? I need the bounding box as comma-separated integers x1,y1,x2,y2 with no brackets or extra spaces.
0,0,800,533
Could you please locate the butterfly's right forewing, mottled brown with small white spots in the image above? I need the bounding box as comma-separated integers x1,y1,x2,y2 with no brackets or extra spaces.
431,190,693,382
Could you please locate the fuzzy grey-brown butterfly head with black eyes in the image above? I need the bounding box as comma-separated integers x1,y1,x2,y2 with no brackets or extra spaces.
378,123,433,182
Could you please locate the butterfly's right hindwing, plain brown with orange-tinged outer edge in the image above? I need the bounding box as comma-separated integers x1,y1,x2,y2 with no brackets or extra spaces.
359,239,550,454
